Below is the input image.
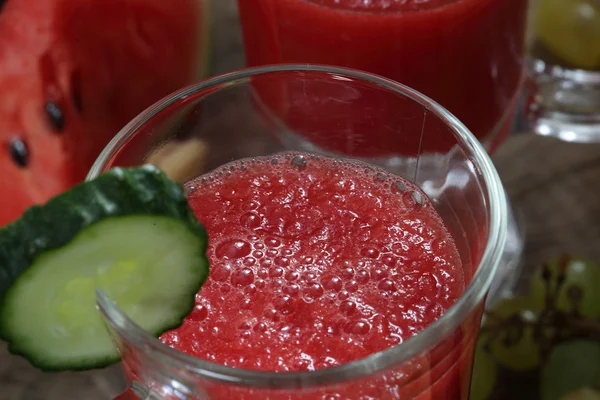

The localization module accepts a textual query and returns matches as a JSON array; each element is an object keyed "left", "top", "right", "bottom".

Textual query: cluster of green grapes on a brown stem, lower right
[{"left": 471, "top": 256, "right": 600, "bottom": 400}]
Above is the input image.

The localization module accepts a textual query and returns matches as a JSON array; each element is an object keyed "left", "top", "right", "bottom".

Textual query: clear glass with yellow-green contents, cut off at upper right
[{"left": 527, "top": 0, "right": 600, "bottom": 143}]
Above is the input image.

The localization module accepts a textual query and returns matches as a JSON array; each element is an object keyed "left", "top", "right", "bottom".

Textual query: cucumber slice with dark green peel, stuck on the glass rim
[{"left": 0, "top": 166, "right": 208, "bottom": 371}]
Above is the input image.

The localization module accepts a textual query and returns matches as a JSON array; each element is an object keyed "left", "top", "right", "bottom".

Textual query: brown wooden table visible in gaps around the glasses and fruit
[{"left": 0, "top": 0, "right": 600, "bottom": 400}]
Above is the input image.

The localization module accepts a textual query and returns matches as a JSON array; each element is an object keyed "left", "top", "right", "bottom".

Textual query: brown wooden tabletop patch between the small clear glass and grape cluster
[{"left": 493, "top": 134, "right": 600, "bottom": 282}]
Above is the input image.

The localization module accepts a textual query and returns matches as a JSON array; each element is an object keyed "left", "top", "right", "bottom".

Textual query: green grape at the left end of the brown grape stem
[{"left": 481, "top": 297, "right": 540, "bottom": 371}]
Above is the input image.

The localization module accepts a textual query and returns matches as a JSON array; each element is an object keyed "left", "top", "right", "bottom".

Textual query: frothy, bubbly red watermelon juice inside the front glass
[{"left": 161, "top": 153, "right": 476, "bottom": 399}]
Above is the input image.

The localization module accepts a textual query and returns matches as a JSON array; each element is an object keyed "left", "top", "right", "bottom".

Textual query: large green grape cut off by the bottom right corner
[{"left": 540, "top": 340, "right": 600, "bottom": 400}]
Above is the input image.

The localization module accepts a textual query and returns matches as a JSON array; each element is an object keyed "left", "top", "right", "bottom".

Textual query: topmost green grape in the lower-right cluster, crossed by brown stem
[{"left": 530, "top": 259, "right": 600, "bottom": 318}]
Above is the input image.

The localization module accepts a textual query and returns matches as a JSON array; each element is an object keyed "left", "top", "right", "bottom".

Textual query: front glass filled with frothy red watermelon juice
[{"left": 88, "top": 65, "right": 507, "bottom": 400}]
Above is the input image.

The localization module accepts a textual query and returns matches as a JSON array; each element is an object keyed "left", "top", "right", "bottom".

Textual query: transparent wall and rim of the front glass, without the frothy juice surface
[{"left": 88, "top": 65, "right": 507, "bottom": 400}]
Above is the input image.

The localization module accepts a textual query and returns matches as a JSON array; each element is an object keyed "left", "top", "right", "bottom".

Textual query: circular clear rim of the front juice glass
[{"left": 86, "top": 64, "right": 508, "bottom": 389}]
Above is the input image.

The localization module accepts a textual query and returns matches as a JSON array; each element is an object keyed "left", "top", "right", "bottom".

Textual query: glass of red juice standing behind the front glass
[{"left": 238, "top": 0, "right": 528, "bottom": 155}]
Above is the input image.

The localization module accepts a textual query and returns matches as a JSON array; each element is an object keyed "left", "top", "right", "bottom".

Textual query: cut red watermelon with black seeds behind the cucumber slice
[{"left": 0, "top": 0, "right": 207, "bottom": 226}]
